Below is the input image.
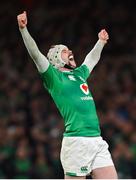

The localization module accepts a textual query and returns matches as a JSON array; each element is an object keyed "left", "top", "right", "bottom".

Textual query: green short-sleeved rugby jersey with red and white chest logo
[{"left": 40, "top": 64, "right": 100, "bottom": 136}]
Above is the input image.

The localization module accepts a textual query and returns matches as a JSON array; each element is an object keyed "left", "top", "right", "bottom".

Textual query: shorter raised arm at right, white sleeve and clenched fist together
[{"left": 83, "top": 29, "right": 109, "bottom": 72}]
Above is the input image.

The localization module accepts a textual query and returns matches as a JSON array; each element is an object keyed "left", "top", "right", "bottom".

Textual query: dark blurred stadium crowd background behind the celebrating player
[{"left": 0, "top": 0, "right": 136, "bottom": 179}]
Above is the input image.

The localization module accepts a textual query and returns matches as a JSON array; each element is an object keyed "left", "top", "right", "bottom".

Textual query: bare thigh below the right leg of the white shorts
[{"left": 91, "top": 166, "right": 118, "bottom": 179}]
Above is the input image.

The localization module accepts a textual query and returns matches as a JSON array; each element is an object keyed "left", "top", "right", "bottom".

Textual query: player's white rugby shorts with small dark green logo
[{"left": 61, "top": 137, "right": 113, "bottom": 176}]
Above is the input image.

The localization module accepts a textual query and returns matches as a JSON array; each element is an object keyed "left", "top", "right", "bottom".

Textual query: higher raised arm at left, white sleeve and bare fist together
[{"left": 17, "top": 11, "right": 49, "bottom": 73}]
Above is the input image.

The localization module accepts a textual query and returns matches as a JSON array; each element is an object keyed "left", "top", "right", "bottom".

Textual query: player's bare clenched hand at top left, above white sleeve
[{"left": 17, "top": 11, "right": 27, "bottom": 29}]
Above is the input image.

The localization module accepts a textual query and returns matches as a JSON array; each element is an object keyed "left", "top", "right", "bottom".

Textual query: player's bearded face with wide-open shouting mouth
[{"left": 61, "top": 48, "right": 76, "bottom": 68}]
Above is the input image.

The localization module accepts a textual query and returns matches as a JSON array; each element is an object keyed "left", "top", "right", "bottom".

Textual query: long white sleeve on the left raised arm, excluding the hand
[{"left": 20, "top": 27, "right": 49, "bottom": 73}]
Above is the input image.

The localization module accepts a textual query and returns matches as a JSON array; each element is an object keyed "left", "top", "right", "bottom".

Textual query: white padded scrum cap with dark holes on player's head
[{"left": 47, "top": 44, "right": 67, "bottom": 68}]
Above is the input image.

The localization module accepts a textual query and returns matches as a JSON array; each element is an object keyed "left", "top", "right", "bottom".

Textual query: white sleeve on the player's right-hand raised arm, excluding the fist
[{"left": 83, "top": 39, "right": 105, "bottom": 72}]
